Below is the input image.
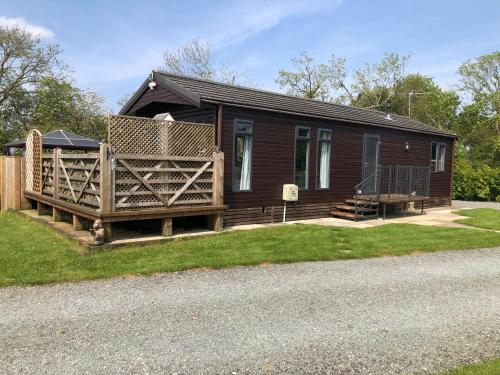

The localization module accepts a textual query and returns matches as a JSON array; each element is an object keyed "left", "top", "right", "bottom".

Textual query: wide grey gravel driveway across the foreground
[{"left": 0, "top": 248, "right": 500, "bottom": 374}]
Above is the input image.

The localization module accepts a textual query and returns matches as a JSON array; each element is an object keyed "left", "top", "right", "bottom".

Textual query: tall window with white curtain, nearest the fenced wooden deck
[{"left": 233, "top": 120, "right": 253, "bottom": 191}]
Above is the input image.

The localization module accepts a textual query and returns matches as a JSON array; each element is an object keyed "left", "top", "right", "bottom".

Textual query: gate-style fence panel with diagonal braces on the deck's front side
[{"left": 114, "top": 154, "right": 213, "bottom": 211}]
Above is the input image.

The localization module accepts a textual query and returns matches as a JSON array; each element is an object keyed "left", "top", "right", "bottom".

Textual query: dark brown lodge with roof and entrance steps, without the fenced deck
[{"left": 120, "top": 72, "right": 456, "bottom": 226}]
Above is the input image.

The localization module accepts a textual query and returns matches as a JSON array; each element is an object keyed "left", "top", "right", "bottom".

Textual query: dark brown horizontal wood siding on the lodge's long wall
[{"left": 222, "top": 106, "right": 453, "bottom": 209}]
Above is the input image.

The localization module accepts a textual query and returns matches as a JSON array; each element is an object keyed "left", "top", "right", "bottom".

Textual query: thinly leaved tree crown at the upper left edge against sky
[{"left": 0, "top": 27, "right": 62, "bottom": 106}]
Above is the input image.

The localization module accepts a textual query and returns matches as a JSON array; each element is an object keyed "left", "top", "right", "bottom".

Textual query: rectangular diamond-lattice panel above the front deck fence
[{"left": 108, "top": 115, "right": 215, "bottom": 156}]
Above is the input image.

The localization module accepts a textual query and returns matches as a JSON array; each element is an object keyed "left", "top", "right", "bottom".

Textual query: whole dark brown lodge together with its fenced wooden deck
[{"left": 17, "top": 72, "right": 455, "bottom": 244}]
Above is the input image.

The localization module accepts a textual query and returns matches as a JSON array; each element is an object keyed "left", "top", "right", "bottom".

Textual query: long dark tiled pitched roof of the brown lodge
[{"left": 124, "top": 72, "right": 456, "bottom": 137}]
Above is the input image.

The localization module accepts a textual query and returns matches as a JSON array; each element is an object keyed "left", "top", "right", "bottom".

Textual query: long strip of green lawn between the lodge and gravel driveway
[{"left": 0, "top": 212, "right": 500, "bottom": 286}]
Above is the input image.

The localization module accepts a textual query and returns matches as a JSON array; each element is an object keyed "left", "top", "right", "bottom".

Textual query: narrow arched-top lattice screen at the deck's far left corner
[{"left": 25, "top": 129, "right": 43, "bottom": 193}]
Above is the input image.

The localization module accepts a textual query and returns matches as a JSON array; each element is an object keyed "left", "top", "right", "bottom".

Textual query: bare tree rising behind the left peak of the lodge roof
[{"left": 160, "top": 39, "right": 255, "bottom": 86}]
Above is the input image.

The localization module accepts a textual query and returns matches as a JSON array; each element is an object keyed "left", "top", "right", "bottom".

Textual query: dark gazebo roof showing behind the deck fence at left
[{"left": 4, "top": 130, "right": 100, "bottom": 150}]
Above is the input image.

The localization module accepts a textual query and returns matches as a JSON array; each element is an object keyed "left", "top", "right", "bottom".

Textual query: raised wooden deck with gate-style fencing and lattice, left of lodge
[{"left": 25, "top": 116, "right": 226, "bottom": 244}]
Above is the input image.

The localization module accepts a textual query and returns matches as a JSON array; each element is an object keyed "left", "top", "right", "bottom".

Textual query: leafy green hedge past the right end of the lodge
[{"left": 453, "top": 159, "right": 500, "bottom": 202}]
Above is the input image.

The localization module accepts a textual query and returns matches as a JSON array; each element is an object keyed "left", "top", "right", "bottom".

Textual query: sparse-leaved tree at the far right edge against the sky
[{"left": 458, "top": 51, "right": 500, "bottom": 137}]
